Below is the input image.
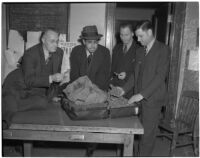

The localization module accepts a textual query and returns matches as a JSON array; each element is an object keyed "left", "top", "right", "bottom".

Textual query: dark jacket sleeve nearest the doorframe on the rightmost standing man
[{"left": 140, "top": 47, "right": 170, "bottom": 99}]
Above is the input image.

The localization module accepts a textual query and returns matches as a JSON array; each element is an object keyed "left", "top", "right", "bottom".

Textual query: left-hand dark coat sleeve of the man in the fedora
[{"left": 70, "top": 47, "right": 79, "bottom": 82}]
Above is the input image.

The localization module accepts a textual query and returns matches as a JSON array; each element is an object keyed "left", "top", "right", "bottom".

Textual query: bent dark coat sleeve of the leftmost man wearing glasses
[{"left": 22, "top": 52, "right": 49, "bottom": 88}]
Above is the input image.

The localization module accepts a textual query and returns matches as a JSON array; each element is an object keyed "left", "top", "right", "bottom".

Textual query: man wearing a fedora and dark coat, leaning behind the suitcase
[{"left": 70, "top": 25, "right": 111, "bottom": 91}]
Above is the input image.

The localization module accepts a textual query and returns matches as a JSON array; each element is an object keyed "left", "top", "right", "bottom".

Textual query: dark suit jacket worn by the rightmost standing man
[{"left": 123, "top": 40, "right": 170, "bottom": 107}]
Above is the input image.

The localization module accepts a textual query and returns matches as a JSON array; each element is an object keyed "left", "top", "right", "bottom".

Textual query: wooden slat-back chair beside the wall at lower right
[{"left": 157, "top": 91, "right": 199, "bottom": 156}]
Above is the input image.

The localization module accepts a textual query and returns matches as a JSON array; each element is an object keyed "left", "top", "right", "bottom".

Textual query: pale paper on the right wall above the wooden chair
[{"left": 188, "top": 49, "right": 199, "bottom": 71}]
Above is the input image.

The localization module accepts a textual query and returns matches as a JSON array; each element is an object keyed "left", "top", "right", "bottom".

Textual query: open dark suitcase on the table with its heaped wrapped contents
[{"left": 61, "top": 76, "right": 136, "bottom": 120}]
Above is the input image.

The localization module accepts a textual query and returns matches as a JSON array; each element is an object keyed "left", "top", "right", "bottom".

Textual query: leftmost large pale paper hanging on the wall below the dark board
[{"left": 8, "top": 30, "right": 24, "bottom": 56}]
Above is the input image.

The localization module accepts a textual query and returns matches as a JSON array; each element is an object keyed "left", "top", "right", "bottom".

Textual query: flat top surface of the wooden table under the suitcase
[{"left": 10, "top": 105, "right": 144, "bottom": 134}]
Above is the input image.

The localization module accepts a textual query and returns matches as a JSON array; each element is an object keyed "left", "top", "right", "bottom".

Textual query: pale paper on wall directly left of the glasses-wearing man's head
[{"left": 26, "top": 31, "right": 42, "bottom": 49}]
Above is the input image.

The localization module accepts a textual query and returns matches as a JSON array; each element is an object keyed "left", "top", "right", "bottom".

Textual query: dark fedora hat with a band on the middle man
[{"left": 80, "top": 25, "right": 103, "bottom": 40}]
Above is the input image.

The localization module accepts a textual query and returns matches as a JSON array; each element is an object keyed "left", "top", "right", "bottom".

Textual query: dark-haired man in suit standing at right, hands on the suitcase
[{"left": 115, "top": 20, "right": 170, "bottom": 156}]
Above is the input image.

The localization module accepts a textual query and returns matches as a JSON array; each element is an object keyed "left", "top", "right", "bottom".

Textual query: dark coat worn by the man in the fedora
[{"left": 70, "top": 45, "right": 111, "bottom": 90}]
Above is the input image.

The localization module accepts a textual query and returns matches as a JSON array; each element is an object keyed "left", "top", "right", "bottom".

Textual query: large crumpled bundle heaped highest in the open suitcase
[{"left": 63, "top": 76, "right": 107, "bottom": 105}]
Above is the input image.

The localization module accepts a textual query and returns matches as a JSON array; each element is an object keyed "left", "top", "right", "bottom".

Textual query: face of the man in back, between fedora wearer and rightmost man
[{"left": 120, "top": 27, "right": 134, "bottom": 44}]
